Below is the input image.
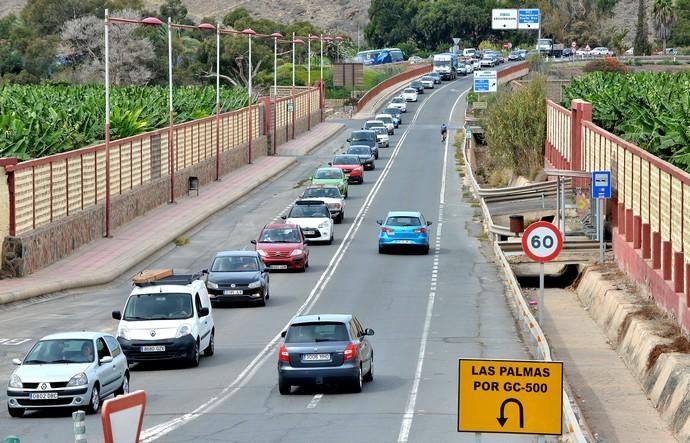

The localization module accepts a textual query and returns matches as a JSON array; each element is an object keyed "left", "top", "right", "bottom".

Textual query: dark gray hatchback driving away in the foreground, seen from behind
[{"left": 278, "top": 314, "right": 374, "bottom": 395}]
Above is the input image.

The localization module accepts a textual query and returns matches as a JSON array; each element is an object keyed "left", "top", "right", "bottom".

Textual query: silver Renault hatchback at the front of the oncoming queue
[{"left": 7, "top": 332, "right": 129, "bottom": 417}]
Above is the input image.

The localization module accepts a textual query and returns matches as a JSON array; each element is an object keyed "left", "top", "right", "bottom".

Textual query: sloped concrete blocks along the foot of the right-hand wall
[{"left": 576, "top": 268, "right": 690, "bottom": 442}]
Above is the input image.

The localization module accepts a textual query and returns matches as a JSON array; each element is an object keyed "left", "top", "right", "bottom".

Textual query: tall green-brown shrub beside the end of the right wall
[{"left": 483, "top": 76, "right": 546, "bottom": 178}]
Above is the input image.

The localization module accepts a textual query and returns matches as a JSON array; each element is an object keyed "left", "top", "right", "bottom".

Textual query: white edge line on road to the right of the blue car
[{"left": 398, "top": 88, "right": 469, "bottom": 443}]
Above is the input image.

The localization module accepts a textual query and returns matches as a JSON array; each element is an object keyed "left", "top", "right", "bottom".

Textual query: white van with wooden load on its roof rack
[{"left": 112, "top": 269, "right": 215, "bottom": 366}]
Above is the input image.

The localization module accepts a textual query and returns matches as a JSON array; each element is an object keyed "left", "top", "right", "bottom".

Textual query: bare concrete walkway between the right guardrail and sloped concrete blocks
[{"left": 544, "top": 288, "right": 677, "bottom": 443}]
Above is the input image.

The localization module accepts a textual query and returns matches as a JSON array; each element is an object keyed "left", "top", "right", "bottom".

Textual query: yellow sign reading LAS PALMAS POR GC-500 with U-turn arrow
[{"left": 458, "top": 358, "right": 563, "bottom": 435}]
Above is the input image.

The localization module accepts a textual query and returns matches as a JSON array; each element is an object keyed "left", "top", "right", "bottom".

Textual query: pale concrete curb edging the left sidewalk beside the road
[{"left": 0, "top": 157, "right": 297, "bottom": 304}]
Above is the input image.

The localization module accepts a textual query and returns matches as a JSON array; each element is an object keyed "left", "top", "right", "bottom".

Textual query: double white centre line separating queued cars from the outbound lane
[{"left": 141, "top": 81, "right": 448, "bottom": 443}]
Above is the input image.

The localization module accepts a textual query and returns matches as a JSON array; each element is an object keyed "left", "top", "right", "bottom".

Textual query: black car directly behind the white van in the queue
[{"left": 206, "top": 251, "right": 270, "bottom": 306}]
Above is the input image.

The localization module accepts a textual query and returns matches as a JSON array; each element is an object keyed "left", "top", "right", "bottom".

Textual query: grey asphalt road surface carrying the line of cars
[{"left": 0, "top": 67, "right": 534, "bottom": 443}]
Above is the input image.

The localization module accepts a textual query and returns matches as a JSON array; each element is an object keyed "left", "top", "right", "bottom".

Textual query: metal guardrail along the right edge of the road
[{"left": 463, "top": 140, "right": 589, "bottom": 443}]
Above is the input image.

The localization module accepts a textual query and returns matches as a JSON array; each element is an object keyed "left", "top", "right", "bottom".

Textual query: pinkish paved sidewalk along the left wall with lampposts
[{"left": 0, "top": 123, "right": 344, "bottom": 304}]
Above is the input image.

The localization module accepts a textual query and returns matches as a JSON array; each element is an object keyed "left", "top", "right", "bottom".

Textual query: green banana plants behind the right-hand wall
[{"left": 563, "top": 72, "right": 690, "bottom": 171}]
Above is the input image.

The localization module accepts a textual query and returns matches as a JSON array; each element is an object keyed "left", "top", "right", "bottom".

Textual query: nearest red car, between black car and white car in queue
[{"left": 252, "top": 223, "right": 309, "bottom": 272}]
